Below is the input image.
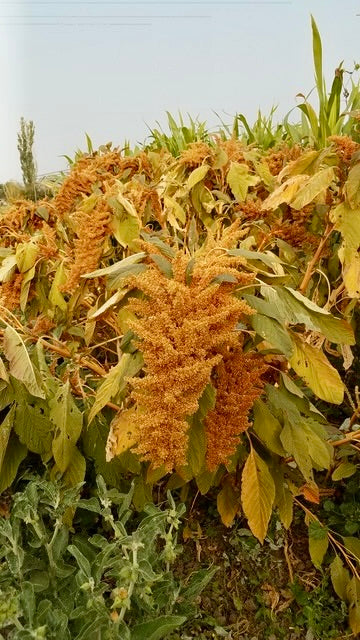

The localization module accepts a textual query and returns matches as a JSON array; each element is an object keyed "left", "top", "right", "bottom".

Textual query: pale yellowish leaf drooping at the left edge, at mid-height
[{"left": 3, "top": 325, "right": 45, "bottom": 398}]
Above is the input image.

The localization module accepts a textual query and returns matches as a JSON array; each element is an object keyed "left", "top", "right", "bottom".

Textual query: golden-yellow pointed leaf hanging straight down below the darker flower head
[{"left": 241, "top": 448, "right": 275, "bottom": 543}]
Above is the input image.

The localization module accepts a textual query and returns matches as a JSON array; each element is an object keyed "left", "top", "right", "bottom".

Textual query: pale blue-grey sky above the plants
[{"left": 0, "top": 0, "right": 360, "bottom": 182}]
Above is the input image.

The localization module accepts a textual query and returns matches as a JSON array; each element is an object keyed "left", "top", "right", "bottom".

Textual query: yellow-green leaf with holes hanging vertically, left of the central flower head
[{"left": 49, "top": 381, "right": 82, "bottom": 473}]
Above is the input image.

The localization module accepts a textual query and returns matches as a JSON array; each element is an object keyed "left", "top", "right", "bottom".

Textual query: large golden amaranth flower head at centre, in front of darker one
[{"left": 125, "top": 248, "right": 253, "bottom": 471}]
